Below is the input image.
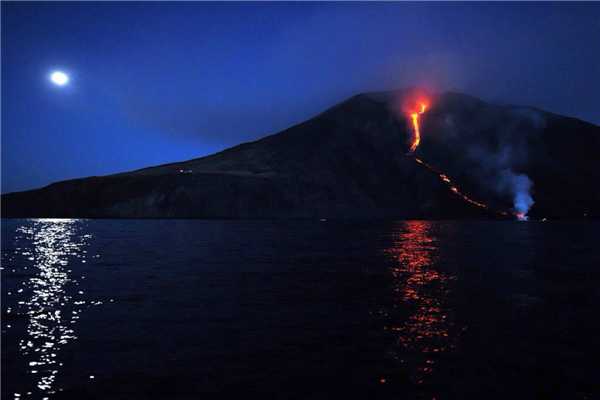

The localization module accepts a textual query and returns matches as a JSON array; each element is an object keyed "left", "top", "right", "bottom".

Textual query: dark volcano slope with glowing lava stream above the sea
[{"left": 2, "top": 90, "right": 600, "bottom": 219}]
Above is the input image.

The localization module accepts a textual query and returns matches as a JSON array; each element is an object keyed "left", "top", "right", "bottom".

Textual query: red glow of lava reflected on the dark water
[{"left": 386, "top": 221, "right": 454, "bottom": 384}]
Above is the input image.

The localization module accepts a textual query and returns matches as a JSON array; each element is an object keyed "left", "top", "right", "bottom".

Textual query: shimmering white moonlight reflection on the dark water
[{"left": 6, "top": 219, "right": 90, "bottom": 399}]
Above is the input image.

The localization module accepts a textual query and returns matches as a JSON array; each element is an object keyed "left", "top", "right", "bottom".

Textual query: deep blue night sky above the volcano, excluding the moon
[{"left": 2, "top": 2, "right": 600, "bottom": 192}]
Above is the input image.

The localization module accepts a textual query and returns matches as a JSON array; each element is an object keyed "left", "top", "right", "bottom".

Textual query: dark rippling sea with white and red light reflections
[{"left": 1, "top": 220, "right": 600, "bottom": 400}]
